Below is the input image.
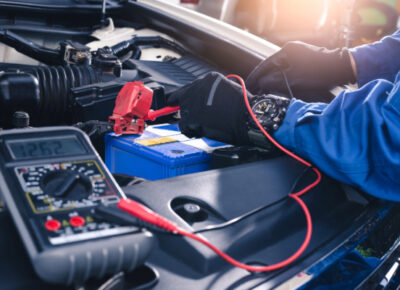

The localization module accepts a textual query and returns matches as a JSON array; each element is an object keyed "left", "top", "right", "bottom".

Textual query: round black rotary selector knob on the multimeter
[{"left": 41, "top": 170, "right": 92, "bottom": 200}]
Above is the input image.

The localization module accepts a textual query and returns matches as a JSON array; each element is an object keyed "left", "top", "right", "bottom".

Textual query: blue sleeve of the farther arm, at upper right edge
[{"left": 350, "top": 30, "right": 400, "bottom": 87}]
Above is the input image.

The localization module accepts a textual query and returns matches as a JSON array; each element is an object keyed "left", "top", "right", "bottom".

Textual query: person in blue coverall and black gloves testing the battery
[{"left": 168, "top": 31, "right": 400, "bottom": 201}]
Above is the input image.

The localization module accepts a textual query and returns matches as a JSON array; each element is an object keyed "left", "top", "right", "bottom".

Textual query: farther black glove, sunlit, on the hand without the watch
[{"left": 246, "top": 42, "right": 356, "bottom": 96}]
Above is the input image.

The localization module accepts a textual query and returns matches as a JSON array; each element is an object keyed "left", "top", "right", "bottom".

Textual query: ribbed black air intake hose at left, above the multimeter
[{"left": 0, "top": 64, "right": 102, "bottom": 125}]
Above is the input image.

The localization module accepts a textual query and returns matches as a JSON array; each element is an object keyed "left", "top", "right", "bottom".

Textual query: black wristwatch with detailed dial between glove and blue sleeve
[{"left": 248, "top": 94, "right": 290, "bottom": 150}]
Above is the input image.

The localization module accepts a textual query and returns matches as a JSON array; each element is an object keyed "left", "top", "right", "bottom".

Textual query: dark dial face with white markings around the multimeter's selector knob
[{"left": 15, "top": 160, "right": 118, "bottom": 213}]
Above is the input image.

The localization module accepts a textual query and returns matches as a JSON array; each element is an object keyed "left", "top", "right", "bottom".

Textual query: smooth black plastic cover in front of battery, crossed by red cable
[{"left": 124, "top": 157, "right": 367, "bottom": 274}]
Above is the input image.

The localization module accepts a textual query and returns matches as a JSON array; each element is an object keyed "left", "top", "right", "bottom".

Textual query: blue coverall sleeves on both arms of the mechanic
[{"left": 274, "top": 30, "right": 400, "bottom": 201}]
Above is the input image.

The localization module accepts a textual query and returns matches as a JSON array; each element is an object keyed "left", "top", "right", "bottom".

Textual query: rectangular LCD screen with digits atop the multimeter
[{"left": 7, "top": 136, "right": 85, "bottom": 160}]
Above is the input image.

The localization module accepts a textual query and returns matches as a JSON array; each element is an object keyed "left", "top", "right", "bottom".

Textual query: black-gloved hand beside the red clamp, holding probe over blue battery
[{"left": 168, "top": 72, "right": 253, "bottom": 145}]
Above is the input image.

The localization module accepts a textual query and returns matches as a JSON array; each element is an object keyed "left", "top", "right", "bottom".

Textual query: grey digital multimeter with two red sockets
[{"left": 0, "top": 127, "right": 154, "bottom": 285}]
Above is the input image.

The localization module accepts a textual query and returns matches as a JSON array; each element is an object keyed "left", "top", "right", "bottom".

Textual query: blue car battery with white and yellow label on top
[{"left": 105, "top": 124, "right": 230, "bottom": 180}]
